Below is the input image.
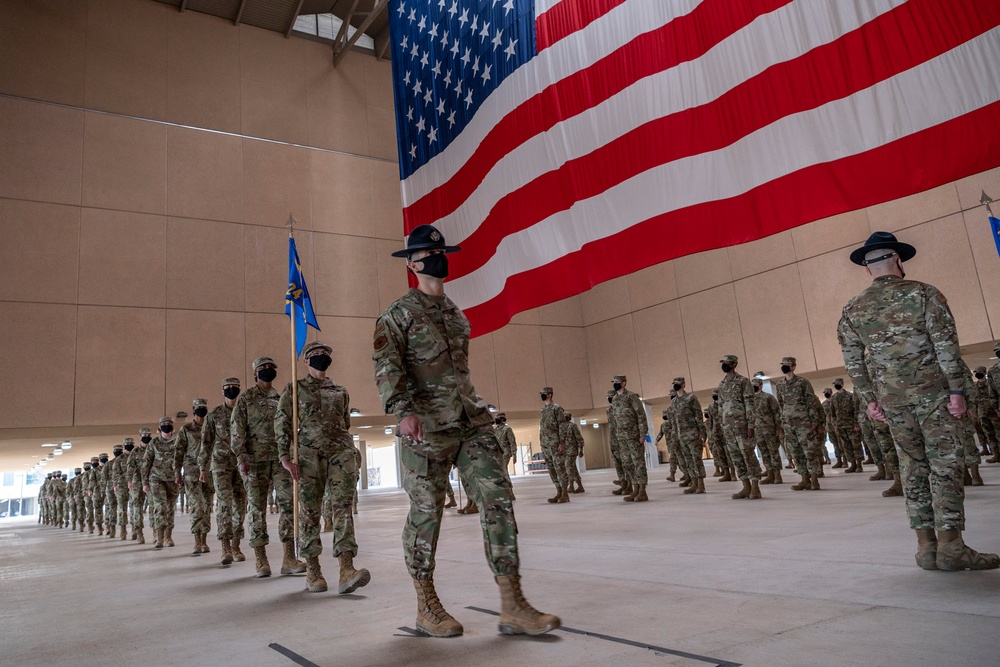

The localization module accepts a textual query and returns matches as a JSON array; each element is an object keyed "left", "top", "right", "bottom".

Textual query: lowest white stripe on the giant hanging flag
[{"left": 448, "top": 28, "right": 1000, "bottom": 308}]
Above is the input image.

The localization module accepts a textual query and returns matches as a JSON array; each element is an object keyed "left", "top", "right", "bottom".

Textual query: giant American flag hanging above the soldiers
[{"left": 389, "top": 0, "right": 1000, "bottom": 335}]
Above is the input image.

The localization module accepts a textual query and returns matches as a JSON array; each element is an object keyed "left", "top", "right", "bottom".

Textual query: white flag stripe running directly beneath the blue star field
[{"left": 402, "top": 0, "right": 702, "bottom": 207}]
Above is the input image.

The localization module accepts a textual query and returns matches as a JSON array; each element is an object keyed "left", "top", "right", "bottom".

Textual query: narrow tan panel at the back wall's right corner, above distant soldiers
[{"left": 537, "top": 327, "right": 593, "bottom": 412}]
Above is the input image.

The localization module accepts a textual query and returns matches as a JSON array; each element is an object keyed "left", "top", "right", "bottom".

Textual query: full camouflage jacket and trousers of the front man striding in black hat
[{"left": 372, "top": 289, "right": 520, "bottom": 580}]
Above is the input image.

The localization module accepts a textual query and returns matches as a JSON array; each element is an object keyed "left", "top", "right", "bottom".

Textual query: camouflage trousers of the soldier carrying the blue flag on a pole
[{"left": 299, "top": 445, "right": 361, "bottom": 557}]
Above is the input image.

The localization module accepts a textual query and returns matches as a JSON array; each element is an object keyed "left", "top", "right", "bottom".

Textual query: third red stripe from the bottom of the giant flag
[{"left": 403, "top": 0, "right": 793, "bottom": 234}]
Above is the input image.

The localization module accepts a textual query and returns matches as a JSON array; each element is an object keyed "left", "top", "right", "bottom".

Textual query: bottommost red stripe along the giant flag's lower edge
[{"left": 465, "top": 102, "right": 1000, "bottom": 336}]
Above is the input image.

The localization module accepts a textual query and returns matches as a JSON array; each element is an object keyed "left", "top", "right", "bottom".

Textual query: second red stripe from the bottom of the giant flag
[{"left": 450, "top": 0, "right": 1000, "bottom": 279}]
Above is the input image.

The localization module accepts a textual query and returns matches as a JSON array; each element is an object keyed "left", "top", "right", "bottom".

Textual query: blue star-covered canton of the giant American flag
[{"left": 389, "top": 0, "right": 535, "bottom": 179}]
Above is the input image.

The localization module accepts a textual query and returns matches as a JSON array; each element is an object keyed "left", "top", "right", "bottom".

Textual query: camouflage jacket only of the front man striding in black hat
[{"left": 372, "top": 289, "right": 493, "bottom": 433}]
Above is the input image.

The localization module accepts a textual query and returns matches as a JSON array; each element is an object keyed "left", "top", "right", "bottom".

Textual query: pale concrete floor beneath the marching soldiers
[{"left": 0, "top": 465, "right": 1000, "bottom": 667}]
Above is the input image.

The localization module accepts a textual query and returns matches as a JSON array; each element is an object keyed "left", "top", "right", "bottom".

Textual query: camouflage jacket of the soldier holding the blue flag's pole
[{"left": 274, "top": 375, "right": 354, "bottom": 461}]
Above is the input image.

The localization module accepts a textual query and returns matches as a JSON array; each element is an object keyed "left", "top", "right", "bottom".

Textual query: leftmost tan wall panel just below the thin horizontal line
[{"left": 0, "top": 98, "right": 83, "bottom": 204}]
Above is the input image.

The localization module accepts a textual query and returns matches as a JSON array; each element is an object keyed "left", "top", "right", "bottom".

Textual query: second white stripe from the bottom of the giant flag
[{"left": 432, "top": 0, "right": 906, "bottom": 243}]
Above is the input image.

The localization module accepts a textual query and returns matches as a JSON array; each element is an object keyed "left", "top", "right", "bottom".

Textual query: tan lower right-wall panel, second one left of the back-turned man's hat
[{"left": 735, "top": 265, "right": 816, "bottom": 377}]
